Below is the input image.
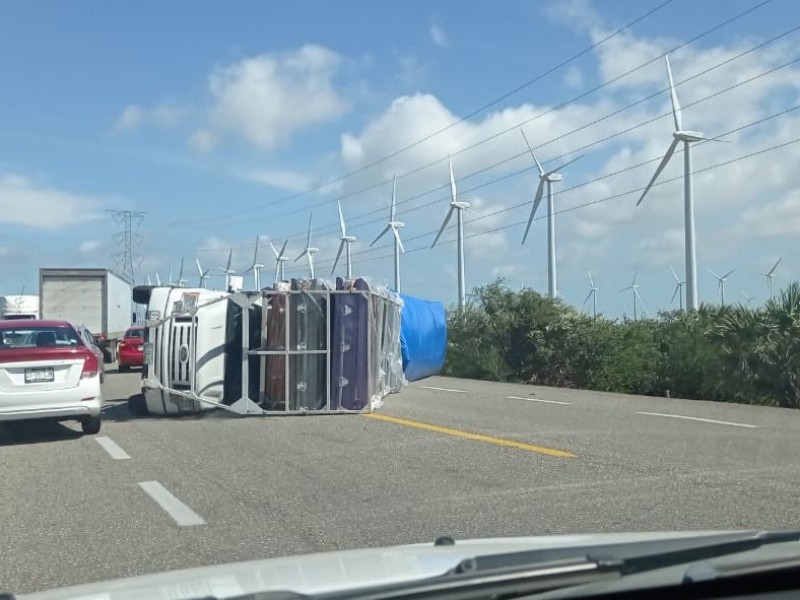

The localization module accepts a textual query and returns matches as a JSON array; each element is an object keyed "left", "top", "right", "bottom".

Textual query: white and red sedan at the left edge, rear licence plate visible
[{"left": 0, "top": 320, "right": 103, "bottom": 434}]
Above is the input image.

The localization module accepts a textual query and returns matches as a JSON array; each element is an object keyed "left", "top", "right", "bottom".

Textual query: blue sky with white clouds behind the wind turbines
[{"left": 0, "top": 0, "right": 800, "bottom": 316}]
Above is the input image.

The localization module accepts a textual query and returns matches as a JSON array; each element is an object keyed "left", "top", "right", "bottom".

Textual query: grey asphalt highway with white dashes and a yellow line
[{"left": 0, "top": 370, "right": 800, "bottom": 593}]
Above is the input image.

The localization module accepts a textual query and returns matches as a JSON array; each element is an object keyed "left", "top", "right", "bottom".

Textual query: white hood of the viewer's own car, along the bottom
[{"left": 18, "top": 531, "right": 744, "bottom": 600}]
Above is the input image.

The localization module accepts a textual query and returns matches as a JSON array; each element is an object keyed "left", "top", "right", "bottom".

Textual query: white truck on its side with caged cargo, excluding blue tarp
[{"left": 134, "top": 278, "right": 405, "bottom": 415}]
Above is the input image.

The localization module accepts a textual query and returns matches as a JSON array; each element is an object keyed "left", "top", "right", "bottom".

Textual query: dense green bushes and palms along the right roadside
[{"left": 443, "top": 280, "right": 800, "bottom": 408}]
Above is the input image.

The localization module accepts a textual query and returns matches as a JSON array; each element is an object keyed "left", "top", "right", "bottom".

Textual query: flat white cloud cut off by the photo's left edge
[{"left": 0, "top": 173, "right": 100, "bottom": 229}]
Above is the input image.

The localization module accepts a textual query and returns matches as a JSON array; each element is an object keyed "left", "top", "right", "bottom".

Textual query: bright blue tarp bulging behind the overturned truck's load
[{"left": 400, "top": 294, "right": 447, "bottom": 381}]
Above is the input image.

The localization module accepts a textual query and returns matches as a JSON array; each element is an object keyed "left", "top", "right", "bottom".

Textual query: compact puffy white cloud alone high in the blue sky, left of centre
[{"left": 209, "top": 44, "right": 346, "bottom": 149}]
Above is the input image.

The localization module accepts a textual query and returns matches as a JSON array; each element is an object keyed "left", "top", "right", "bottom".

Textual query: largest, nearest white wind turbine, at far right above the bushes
[{"left": 636, "top": 56, "right": 719, "bottom": 311}]
